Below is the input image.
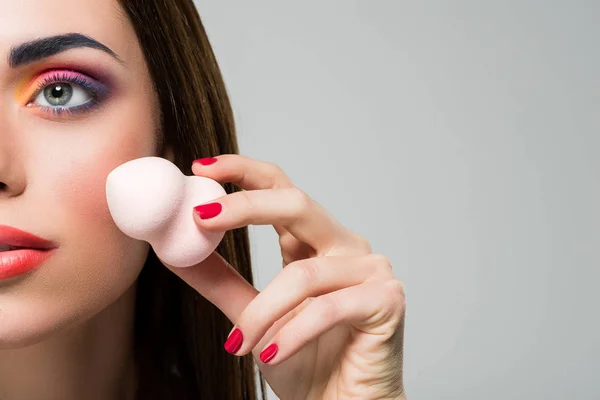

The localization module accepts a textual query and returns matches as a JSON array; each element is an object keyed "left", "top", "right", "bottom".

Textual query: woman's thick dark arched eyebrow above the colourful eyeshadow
[{"left": 8, "top": 33, "right": 123, "bottom": 68}]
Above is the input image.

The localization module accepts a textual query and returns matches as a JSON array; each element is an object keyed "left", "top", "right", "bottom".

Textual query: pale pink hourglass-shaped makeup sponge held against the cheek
[{"left": 106, "top": 157, "right": 227, "bottom": 267}]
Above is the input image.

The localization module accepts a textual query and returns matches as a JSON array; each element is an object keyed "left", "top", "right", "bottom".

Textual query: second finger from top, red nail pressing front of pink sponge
[{"left": 194, "top": 188, "right": 347, "bottom": 252}]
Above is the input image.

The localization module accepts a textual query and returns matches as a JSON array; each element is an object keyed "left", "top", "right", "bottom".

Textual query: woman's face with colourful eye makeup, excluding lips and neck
[{"left": 0, "top": 0, "right": 158, "bottom": 348}]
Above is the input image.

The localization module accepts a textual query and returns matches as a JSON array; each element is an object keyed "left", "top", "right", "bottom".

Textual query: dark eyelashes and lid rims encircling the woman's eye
[{"left": 28, "top": 70, "right": 108, "bottom": 117}]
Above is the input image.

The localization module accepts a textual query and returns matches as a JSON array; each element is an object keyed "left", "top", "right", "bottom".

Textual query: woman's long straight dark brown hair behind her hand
[{"left": 119, "top": 0, "right": 265, "bottom": 400}]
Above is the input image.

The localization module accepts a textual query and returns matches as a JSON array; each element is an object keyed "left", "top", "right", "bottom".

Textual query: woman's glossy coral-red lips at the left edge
[{"left": 0, "top": 225, "right": 57, "bottom": 280}]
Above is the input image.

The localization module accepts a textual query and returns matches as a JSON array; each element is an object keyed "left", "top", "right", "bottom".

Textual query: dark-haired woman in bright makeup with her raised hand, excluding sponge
[{"left": 0, "top": 0, "right": 405, "bottom": 400}]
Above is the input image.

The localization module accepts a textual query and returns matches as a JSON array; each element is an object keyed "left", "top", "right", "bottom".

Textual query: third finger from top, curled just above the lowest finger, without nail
[{"left": 218, "top": 254, "right": 393, "bottom": 355}]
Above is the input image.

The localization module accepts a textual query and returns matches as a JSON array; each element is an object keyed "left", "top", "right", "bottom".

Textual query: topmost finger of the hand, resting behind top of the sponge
[{"left": 192, "top": 154, "right": 294, "bottom": 190}]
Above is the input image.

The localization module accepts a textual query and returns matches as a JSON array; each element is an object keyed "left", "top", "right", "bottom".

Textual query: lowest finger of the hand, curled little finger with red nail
[{"left": 254, "top": 280, "right": 405, "bottom": 365}]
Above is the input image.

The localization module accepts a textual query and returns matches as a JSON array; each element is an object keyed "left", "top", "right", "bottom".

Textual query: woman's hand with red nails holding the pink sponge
[{"left": 164, "top": 154, "right": 405, "bottom": 400}]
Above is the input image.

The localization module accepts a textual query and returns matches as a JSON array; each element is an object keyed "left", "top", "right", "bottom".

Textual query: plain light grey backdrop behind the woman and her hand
[{"left": 197, "top": 0, "right": 600, "bottom": 400}]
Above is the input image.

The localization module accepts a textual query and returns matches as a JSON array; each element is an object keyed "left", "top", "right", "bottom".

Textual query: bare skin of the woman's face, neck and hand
[{"left": 0, "top": 0, "right": 405, "bottom": 400}]
